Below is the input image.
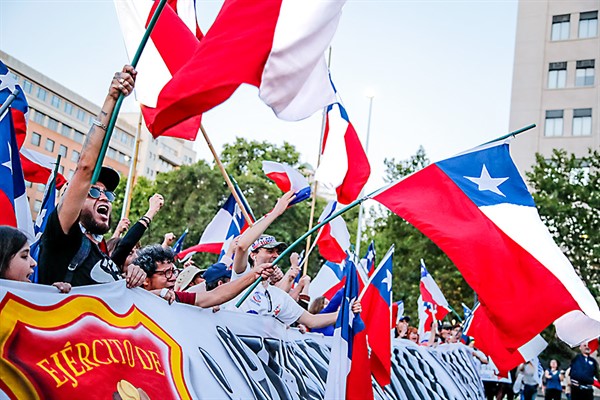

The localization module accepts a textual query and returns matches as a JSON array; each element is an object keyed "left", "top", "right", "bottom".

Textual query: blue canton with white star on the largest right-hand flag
[{"left": 437, "top": 143, "right": 535, "bottom": 207}]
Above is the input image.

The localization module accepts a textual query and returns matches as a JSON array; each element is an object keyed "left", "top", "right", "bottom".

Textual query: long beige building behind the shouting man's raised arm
[{"left": 0, "top": 51, "right": 196, "bottom": 219}]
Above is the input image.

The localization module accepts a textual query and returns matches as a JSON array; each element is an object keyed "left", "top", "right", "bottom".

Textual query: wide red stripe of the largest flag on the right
[{"left": 374, "top": 165, "right": 579, "bottom": 349}]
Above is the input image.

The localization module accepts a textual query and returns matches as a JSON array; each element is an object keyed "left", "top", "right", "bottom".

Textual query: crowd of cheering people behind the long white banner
[{"left": 0, "top": 66, "right": 598, "bottom": 400}]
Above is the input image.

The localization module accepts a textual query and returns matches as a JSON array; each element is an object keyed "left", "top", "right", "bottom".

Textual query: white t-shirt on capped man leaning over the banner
[{"left": 225, "top": 276, "right": 304, "bottom": 325}]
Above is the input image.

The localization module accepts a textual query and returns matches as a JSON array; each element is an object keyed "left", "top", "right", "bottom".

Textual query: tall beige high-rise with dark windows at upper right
[{"left": 510, "top": 0, "right": 600, "bottom": 171}]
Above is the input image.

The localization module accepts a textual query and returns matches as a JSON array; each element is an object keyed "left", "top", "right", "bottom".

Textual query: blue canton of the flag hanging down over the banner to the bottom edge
[{"left": 335, "top": 260, "right": 365, "bottom": 360}]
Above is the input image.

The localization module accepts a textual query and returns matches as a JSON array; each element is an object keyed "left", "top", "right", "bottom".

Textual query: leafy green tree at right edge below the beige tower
[{"left": 527, "top": 149, "right": 600, "bottom": 301}]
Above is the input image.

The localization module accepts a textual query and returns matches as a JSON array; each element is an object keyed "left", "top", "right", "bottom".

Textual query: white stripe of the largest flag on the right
[{"left": 480, "top": 204, "right": 600, "bottom": 322}]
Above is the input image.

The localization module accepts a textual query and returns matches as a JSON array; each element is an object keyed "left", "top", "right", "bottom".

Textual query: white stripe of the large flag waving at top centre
[{"left": 260, "top": 0, "right": 344, "bottom": 120}]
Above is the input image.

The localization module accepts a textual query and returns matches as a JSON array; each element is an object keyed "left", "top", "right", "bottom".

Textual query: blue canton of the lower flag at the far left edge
[{"left": 0, "top": 113, "right": 25, "bottom": 203}]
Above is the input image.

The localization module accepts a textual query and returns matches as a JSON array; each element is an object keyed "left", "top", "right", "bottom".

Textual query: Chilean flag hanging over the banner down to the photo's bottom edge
[{"left": 325, "top": 248, "right": 372, "bottom": 400}]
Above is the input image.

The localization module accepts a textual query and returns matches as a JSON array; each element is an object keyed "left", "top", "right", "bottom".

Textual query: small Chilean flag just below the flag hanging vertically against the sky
[{"left": 317, "top": 201, "right": 350, "bottom": 263}]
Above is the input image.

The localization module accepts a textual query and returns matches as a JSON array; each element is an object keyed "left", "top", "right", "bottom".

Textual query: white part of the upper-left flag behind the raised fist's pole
[{"left": 114, "top": 0, "right": 171, "bottom": 107}]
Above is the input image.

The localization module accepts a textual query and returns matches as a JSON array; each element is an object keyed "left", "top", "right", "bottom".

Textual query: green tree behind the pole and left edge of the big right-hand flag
[{"left": 370, "top": 147, "right": 473, "bottom": 319}]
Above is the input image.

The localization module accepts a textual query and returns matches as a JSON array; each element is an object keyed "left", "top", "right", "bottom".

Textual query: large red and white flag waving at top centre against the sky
[{"left": 135, "top": 0, "right": 344, "bottom": 136}]
